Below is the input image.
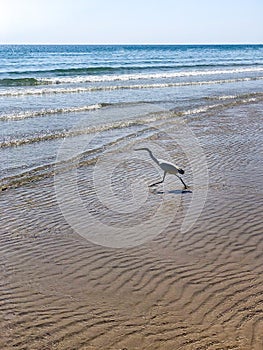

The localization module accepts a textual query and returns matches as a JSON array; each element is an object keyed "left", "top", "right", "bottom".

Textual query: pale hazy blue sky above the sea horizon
[{"left": 0, "top": 0, "right": 263, "bottom": 44}]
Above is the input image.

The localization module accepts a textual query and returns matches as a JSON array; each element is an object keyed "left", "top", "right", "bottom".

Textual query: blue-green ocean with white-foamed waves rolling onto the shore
[{"left": 0, "top": 45, "right": 263, "bottom": 189}]
